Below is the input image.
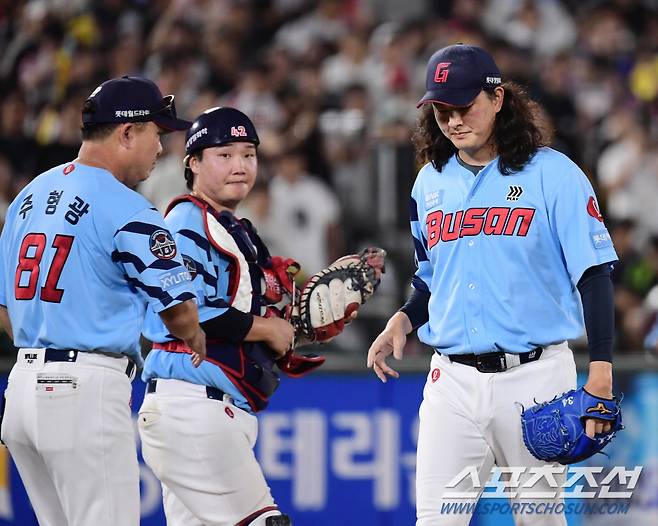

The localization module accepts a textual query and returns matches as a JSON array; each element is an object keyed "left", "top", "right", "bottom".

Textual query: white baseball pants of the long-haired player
[{"left": 416, "top": 343, "right": 576, "bottom": 526}]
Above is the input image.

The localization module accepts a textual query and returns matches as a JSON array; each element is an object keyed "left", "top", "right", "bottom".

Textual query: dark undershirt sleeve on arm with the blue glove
[{"left": 578, "top": 263, "right": 615, "bottom": 363}]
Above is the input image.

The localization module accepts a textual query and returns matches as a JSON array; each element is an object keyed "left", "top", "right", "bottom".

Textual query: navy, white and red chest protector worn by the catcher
[{"left": 167, "top": 194, "right": 279, "bottom": 412}]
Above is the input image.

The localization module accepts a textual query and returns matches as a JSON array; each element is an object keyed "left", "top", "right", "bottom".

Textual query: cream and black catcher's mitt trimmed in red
[{"left": 292, "top": 247, "right": 386, "bottom": 343}]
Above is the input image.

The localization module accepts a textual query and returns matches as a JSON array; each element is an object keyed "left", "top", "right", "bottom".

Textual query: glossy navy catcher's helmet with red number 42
[{"left": 185, "top": 106, "right": 260, "bottom": 155}]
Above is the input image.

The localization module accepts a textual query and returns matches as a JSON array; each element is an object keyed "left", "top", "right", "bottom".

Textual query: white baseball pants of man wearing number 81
[{"left": 2, "top": 349, "right": 139, "bottom": 526}]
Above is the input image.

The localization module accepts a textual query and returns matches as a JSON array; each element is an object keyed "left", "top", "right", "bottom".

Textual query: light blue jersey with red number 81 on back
[{"left": 0, "top": 163, "right": 194, "bottom": 364}]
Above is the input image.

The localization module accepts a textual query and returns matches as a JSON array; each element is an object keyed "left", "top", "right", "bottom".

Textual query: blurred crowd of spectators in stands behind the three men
[{"left": 0, "top": 0, "right": 658, "bottom": 355}]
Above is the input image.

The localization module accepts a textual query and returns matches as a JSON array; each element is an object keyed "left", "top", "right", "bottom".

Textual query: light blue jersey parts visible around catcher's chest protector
[{"left": 142, "top": 202, "right": 252, "bottom": 412}]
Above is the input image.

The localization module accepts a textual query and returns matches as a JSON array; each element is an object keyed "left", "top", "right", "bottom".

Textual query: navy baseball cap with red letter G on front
[{"left": 416, "top": 44, "right": 502, "bottom": 108}]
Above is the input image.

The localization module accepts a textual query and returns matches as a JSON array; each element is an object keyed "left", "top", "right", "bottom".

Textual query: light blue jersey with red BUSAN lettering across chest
[{"left": 410, "top": 148, "right": 617, "bottom": 354}]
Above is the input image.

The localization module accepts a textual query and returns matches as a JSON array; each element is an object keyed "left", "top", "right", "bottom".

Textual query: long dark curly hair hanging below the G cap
[{"left": 412, "top": 82, "right": 552, "bottom": 175}]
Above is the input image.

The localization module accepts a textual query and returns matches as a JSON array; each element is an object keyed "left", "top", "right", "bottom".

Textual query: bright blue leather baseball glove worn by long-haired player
[{"left": 521, "top": 387, "right": 624, "bottom": 464}]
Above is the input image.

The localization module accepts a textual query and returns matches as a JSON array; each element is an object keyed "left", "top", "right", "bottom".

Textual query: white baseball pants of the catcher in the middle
[{"left": 139, "top": 380, "right": 274, "bottom": 526}]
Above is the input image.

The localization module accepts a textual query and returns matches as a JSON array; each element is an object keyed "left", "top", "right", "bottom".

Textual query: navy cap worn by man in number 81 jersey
[{"left": 82, "top": 75, "right": 192, "bottom": 131}]
